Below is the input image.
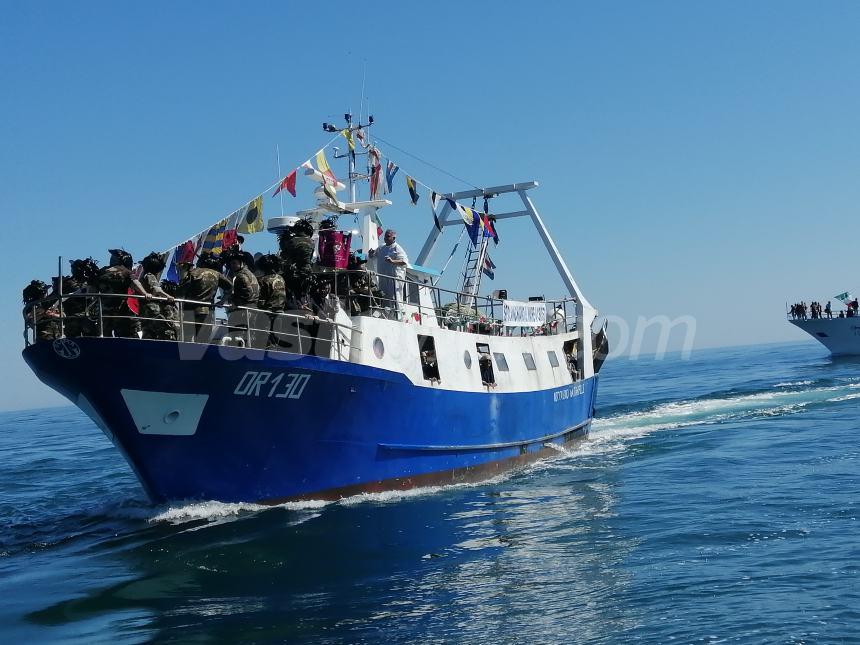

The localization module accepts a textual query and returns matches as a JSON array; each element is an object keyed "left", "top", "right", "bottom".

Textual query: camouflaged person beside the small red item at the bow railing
[{"left": 96, "top": 249, "right": 149, "bottom": 338}]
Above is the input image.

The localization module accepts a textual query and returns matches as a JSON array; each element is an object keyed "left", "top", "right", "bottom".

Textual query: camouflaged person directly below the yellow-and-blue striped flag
[{"left": 178, "top": 251, "right": 233, "bottom": 343}]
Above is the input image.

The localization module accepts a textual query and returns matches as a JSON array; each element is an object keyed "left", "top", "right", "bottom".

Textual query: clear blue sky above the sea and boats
[{"left": 0, "top": 0, "right": 860, "bottom": 408}]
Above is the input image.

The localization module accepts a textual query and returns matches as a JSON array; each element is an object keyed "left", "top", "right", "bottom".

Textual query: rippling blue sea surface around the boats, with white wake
[{"left": 0, "top": 343, "right": 860, "bottom": 644}]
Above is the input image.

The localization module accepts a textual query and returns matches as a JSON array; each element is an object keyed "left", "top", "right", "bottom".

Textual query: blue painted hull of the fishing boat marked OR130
[{"left": 24, "top": 338, "right": 597, "bottom": 503}]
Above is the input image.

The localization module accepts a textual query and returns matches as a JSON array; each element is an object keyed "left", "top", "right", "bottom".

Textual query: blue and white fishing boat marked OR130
[{"left": 23, "top": 119, "right": 608, "bottom": 503}]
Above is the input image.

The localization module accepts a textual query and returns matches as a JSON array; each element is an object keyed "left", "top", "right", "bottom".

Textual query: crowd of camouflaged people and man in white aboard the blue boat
[{"left": 23, "top": 219, "right": 408, "bottom": 348}]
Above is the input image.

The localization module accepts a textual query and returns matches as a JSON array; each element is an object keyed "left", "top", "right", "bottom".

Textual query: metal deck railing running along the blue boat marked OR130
[{"left": 23, "top": 269, "right": 576, "bottom": 350}]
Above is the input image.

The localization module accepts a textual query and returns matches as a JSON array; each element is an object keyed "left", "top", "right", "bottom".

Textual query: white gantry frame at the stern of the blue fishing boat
[{"left": 416, "top": 181, "right": 597, "bottom": 378}]
